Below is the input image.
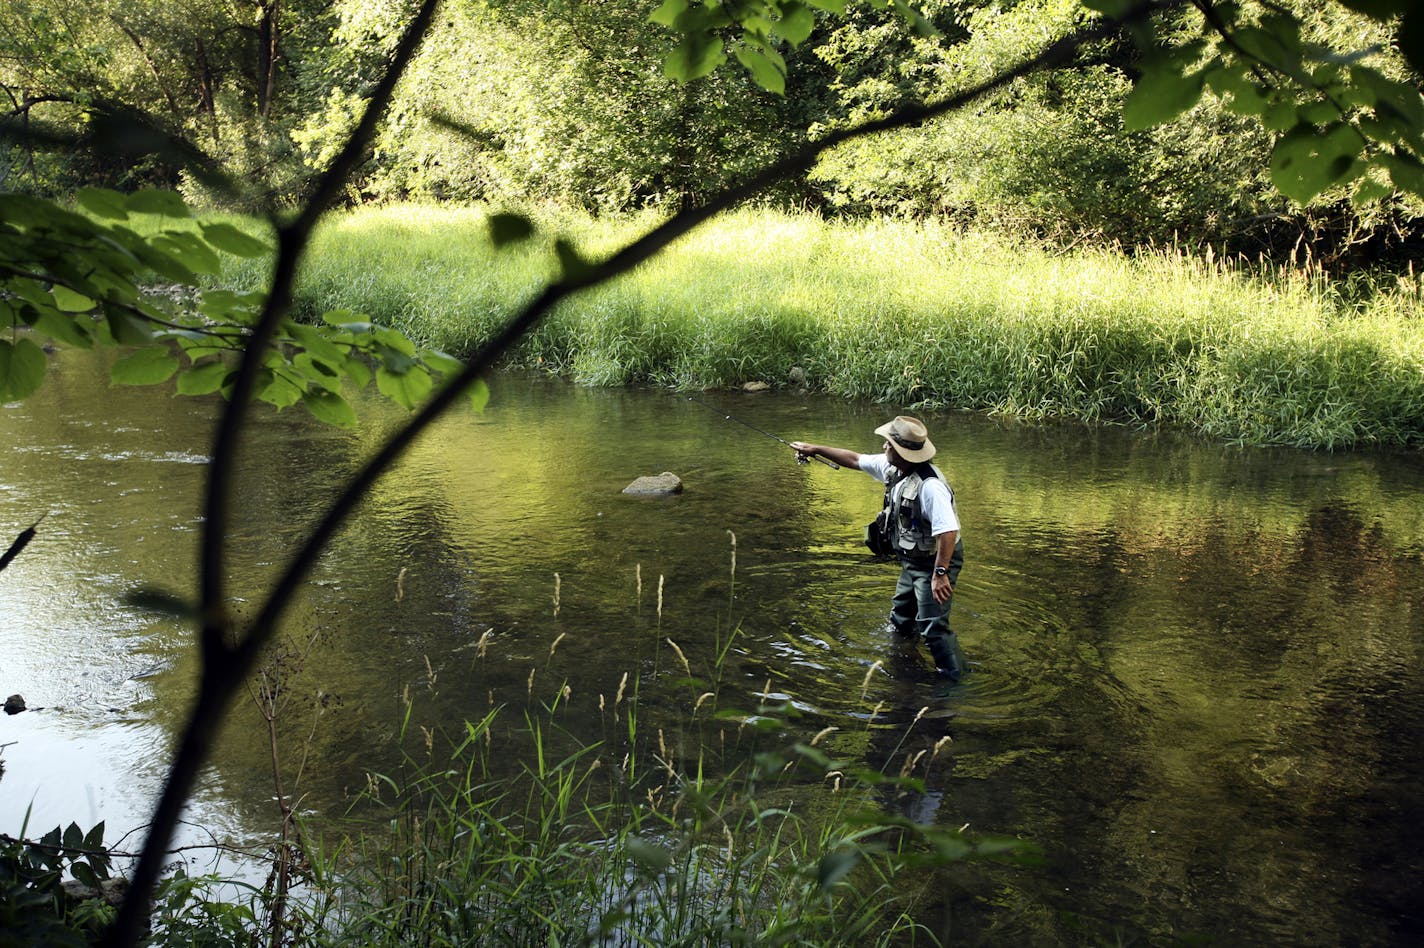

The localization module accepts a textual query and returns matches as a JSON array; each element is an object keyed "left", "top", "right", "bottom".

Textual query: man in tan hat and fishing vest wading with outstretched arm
[{"left": 790, "top": 414, "right": 968, "bottom": 680}]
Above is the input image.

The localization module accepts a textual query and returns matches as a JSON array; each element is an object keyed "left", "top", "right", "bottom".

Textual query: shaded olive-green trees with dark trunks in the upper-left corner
[{"left": 0, "top": 0, "right": 338, "bottom": 202}]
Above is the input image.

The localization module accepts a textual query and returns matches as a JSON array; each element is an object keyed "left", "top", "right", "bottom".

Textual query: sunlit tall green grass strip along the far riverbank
[{"left": 224, "top": 206, "right": 1424, "bottom": 448}]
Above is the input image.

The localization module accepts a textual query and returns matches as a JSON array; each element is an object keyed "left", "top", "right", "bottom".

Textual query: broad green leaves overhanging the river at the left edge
[{"left": 0, "top": 189, "right": 483, "bottom": 418}]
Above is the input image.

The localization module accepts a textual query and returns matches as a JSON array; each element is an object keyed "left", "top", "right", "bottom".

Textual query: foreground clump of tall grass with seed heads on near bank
[{"left": 311, "top": 680, "right": 974, "bottom": 948}]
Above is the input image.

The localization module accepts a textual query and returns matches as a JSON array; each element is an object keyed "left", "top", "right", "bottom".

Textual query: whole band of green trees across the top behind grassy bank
[{"left": 8, "top": 0, "right": 1424, "bottom": 249}]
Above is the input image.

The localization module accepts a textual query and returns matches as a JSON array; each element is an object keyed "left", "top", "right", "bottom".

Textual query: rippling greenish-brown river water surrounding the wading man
[{"left": 0, "top": 353, "right": 1424, "bottom": 945}]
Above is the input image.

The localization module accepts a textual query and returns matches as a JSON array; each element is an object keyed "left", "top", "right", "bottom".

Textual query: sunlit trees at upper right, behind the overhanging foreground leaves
[{"left": 812, "top": 0, "right": 1418, "bottom": 243}]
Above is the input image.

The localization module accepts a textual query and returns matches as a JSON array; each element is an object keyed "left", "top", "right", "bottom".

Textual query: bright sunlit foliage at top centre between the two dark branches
[{"left": 295, "top": 0, "right": 802, "bottom": 209}]
